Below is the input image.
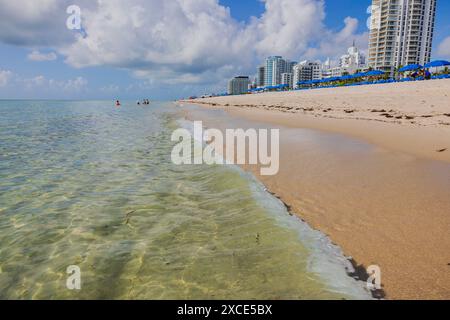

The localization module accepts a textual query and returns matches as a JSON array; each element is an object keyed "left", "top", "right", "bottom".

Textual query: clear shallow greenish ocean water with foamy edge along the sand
[{"left": 0, "top": 101, "right": 370, "bottom": 299}]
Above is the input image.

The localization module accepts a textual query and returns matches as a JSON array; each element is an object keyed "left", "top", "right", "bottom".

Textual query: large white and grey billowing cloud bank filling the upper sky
[{"left": 0, "top": 0, "right": 367, "bottom": 85}]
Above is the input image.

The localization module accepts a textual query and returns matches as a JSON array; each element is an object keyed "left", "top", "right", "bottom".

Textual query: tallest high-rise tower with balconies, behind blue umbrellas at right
[{"left": 368, "top": 0, "right": 436, "bottom": 72}]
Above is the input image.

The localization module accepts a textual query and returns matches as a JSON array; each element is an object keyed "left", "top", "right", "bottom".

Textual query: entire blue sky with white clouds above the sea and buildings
[{"left": 0, "top": 0, "right": 450, "bottom": 99}]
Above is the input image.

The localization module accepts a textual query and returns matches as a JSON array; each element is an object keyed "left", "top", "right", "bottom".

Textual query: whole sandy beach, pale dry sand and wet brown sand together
[{"left": 181, "top": 80, "right": 450, "bottom": 299}]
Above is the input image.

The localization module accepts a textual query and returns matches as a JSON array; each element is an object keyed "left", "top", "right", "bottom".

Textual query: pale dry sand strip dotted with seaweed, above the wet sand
[{"left": 180, "top": 80, "right": 450, "bottom": 162}]
